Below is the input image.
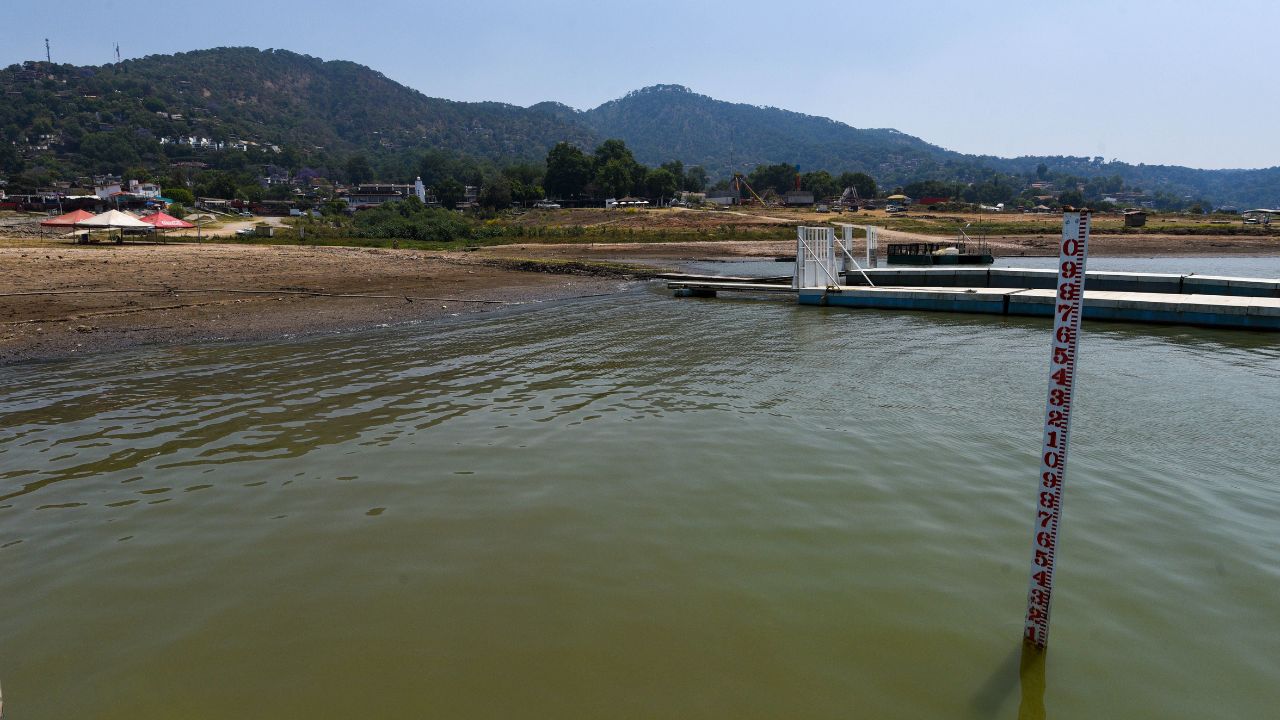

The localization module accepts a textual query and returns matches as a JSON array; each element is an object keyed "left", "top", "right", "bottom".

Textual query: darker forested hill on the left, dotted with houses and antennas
[{"left": 0, "top": 47, "right": 596, "bottom": 172}]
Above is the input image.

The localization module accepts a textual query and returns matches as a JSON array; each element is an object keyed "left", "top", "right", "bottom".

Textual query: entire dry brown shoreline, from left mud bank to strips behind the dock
[{"left": 0, "top": 231, "right": 1280, "bottom": 365}]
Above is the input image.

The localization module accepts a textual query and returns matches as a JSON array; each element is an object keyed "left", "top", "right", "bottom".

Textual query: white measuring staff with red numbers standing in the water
[{"left": 1023, "top": 210, "right": 1091, "bottom": 650}]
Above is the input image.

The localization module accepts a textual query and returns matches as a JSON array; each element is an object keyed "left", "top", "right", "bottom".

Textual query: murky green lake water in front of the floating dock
[{"left": 0, "top": 266, "right": 1280, "bottom": 720}]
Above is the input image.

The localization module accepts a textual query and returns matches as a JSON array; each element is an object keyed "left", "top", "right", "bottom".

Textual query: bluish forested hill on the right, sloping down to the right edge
[{"left": 580, "top": 85, "right": 1280, "bottom": 209}]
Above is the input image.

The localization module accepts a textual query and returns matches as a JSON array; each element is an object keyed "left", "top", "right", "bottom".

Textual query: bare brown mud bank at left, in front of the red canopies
[{"left": 0, "top": 245, "right": 634, "bottom": 364}]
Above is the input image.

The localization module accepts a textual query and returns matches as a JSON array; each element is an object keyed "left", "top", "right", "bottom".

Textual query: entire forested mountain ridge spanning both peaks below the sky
[{"left": 0, "top": 47, "right": 1280, "bottom": 208}]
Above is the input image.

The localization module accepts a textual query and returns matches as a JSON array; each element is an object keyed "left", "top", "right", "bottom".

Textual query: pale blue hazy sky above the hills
[{"left": 0, "top": 0, "right": 1280, "bottom": 168}]
